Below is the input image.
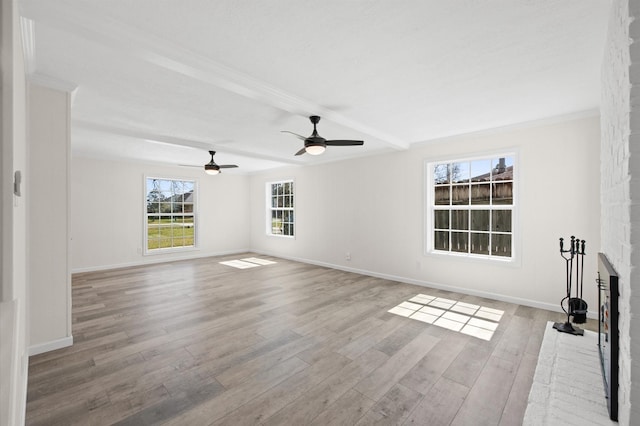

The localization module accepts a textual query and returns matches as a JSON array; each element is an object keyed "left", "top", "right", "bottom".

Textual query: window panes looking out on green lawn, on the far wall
[{"left": 145, "top": 178, "right": 196, "bottom": 252}]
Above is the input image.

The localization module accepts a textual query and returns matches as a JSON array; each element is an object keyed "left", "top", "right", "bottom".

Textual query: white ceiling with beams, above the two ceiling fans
[{"left": 20, "top": 0, "right": 610, "bottom": 173}]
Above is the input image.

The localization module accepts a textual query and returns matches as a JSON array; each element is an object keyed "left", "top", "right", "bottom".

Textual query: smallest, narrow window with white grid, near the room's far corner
[{"left": 267, "top": 180, "right": 295, "bottom": 237}]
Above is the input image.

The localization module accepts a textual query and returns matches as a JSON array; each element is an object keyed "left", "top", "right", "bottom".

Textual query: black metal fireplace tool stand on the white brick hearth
[{"left": 553, "top": 235, "right": 588, "bottom": 336}]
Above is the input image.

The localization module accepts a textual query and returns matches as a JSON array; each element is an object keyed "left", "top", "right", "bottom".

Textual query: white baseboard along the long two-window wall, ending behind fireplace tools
[{"left": 253, "top": 250, "right": 598, "bottom": 319}]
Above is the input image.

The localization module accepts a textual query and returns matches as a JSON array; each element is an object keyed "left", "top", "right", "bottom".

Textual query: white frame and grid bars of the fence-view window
[{"left": 423, "top": 149, "right": 521, "bottom": 266}]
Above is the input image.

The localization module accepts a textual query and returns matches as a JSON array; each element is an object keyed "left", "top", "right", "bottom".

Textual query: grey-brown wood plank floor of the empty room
[{"left": 26, "top": 254, "right": 561, "bottom": 426}]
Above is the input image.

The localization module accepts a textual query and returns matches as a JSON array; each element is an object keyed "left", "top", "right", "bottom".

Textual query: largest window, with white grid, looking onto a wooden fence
[{"left": 426, "top": 154, "right": 516, "bottom": 259}]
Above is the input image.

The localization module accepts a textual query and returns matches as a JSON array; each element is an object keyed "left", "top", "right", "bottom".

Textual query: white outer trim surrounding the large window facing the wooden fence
[{"left": 423, "top": 148, "right": 521, "bottom": 267}]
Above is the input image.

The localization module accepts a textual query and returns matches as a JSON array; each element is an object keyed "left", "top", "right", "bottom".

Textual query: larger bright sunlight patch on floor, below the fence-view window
[{"left": 387, "top": 294, "right": 504, "bottom": 340}]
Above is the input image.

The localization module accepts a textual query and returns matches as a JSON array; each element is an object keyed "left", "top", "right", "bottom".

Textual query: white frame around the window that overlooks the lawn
[{"left": 142, "top": 175, "right": 200, "bottom": 256}]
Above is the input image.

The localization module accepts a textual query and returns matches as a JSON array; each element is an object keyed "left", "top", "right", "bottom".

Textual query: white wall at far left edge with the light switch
[{"left": 0, "top": 0, "right": 29, "bottom": 425}]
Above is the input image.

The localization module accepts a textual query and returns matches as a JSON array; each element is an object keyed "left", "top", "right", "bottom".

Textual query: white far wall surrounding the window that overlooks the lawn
[{"left": 71, "top": 157, "right": 249, "bottom": 272}]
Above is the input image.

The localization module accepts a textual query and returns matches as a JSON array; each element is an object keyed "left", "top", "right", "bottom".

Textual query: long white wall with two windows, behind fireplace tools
[{"left": 251, "top": 116, "right": 600, "bottom": 315}]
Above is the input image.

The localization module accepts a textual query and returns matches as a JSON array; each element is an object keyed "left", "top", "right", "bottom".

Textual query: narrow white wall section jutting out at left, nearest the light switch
[{"left": 28, "top": 84, "right": 73, "bottom": 355}]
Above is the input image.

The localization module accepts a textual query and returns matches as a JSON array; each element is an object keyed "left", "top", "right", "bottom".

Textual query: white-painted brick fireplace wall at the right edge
[{"left": 600, "top": 0, "right": 640, "bottom": 424}]
